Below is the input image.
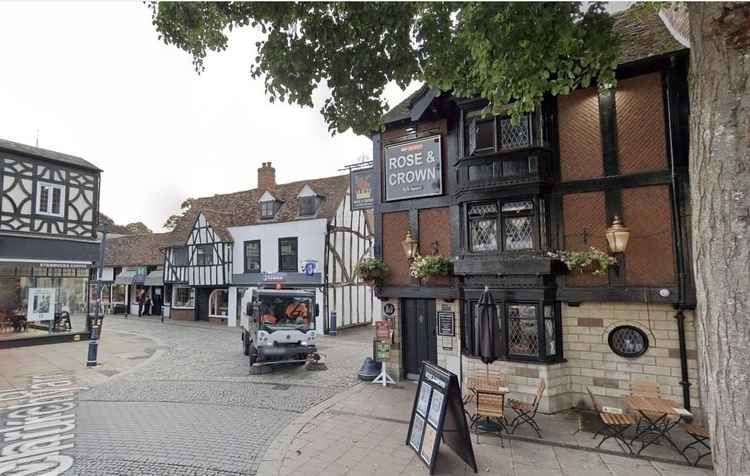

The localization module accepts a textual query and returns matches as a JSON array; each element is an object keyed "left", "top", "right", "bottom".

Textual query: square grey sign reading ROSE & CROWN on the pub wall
[{"left": 383, "top": 136, "right": 443, "bottom": 201}]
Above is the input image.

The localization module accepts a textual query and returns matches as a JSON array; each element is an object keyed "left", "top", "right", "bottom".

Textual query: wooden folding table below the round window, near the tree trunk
[{"left": 625, "top": 395, "right": 687, "bottom": 454}]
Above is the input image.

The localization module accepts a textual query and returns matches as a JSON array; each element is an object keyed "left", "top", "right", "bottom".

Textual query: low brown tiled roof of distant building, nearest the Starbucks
[{"left": 104, "top": 233, "right": 174, "bottom": 266}]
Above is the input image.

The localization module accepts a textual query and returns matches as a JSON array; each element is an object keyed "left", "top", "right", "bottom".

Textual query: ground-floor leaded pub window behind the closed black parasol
[{"left": 461, "top": 301, "right": 562, "bottom": 362}]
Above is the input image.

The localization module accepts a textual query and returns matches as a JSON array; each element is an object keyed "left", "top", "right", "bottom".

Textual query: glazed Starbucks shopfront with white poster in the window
[{"left": 0, "top": 262, "right": 96, "bottom": 347}]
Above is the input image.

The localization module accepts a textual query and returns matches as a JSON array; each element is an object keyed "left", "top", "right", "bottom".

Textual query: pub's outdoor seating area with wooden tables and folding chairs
[{"left": 463, "top": 369, "right": 711, "bottom": 466}]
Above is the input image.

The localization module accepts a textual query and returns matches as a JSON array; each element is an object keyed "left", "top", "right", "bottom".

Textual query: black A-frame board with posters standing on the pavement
[{"left": 406, "top": 362, "right": 477, "bottom": 474}]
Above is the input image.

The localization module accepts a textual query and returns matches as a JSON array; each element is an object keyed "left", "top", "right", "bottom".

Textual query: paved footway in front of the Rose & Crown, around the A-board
[{"left": 258, "top": 382, "right": 713, "bottom": 476}]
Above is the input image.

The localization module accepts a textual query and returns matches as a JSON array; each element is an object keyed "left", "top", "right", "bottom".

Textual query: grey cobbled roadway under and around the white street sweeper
[{"left": 67, "top": 317, "right": 372, "bottom": 476}]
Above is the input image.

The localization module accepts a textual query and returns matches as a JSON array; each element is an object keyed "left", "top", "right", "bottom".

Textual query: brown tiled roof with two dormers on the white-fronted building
[{"left": 173, "top": 175, "right": 349, "bottom": 245}]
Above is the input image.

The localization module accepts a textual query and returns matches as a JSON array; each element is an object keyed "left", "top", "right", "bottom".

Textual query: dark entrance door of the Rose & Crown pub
[{"left": 401, "top": 299, "right": 437, "bottom": 379}]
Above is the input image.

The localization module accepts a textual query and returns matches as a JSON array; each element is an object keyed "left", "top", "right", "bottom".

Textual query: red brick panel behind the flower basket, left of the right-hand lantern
[{"left": 563, "top": 192, "right": 609, "bottom": 286}]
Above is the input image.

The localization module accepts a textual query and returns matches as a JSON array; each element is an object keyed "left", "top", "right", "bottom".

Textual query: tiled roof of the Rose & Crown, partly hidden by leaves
[{"left": 383, "top": 8, "right": 685, "bottom": 124}]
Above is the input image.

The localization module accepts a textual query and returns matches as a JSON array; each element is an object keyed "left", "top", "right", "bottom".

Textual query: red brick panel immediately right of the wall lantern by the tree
[{"left": 622, "top": 185, "right": 677, "bottom": 286}]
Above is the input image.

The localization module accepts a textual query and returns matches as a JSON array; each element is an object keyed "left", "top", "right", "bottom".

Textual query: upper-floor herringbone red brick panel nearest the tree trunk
[{"left": 615, "top": 73, "right": 667, "bottom": 174}]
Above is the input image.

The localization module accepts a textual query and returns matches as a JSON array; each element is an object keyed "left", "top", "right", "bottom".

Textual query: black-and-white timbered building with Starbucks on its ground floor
[{"left": 0, "top": 140, "right": 101, "bottom": 348}]
